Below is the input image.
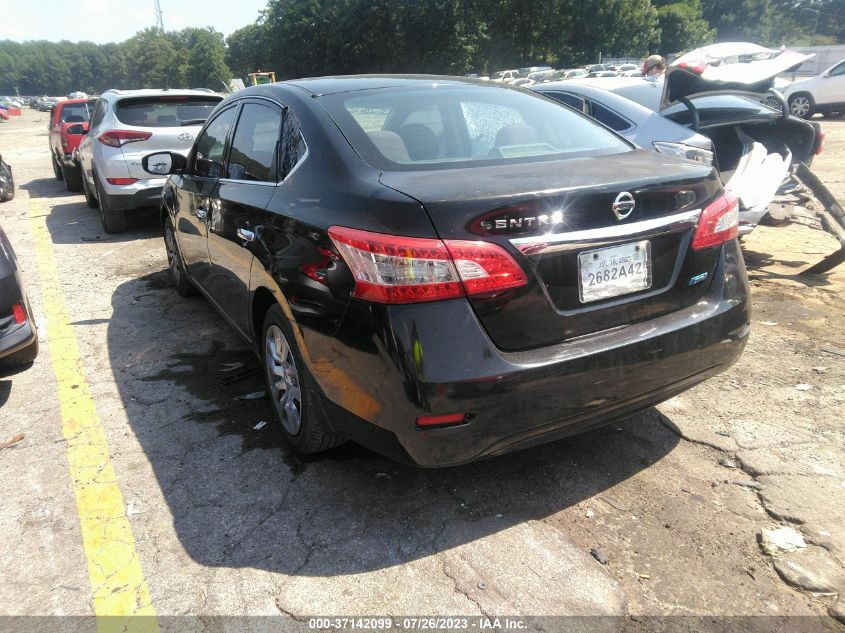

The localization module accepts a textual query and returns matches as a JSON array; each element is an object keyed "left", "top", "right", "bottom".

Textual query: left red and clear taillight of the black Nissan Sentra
[{"left": 329, "top": 226, "right": 528, "bottom": 303}]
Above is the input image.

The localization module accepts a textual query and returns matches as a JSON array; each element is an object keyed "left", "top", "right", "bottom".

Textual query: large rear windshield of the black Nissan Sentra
[{"left": 320, "top": 85, "right": 631, "bottom": 171}]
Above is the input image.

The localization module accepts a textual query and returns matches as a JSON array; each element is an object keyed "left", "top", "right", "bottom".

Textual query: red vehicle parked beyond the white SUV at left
[{"left": 47, "top": 99, "right": 96, "bottom": 191}]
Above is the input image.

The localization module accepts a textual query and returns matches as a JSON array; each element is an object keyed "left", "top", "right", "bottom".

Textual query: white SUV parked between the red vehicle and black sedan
[{"left": 76, "top": 90, "right": 222, "bottom": 233}]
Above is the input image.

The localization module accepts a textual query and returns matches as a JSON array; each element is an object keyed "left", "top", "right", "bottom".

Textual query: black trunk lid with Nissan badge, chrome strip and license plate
[{"left": 380, "top": 150, "right": 720, "bottom": 350}]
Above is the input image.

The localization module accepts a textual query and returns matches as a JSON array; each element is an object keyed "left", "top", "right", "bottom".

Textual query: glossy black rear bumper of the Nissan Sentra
[{"left": 304, "top": 241, "right": 750, "bottom": 466}]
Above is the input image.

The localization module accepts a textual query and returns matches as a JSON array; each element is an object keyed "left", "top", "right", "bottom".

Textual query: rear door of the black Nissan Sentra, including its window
[{"left": 206, "top": 99, "right": 282, "bottom": 335}]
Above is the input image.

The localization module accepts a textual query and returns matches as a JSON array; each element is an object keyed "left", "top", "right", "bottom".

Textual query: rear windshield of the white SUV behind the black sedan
[{"left": 114, "top": 95, "right": 222, "bottom": 127}]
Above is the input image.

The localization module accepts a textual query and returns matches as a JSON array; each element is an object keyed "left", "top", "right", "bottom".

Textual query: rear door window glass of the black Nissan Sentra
[{"left": 227, "top": 103, "right": 282, "bottom": 182}]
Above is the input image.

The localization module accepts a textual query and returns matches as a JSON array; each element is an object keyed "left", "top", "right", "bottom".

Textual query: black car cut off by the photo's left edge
[{"left": 0, "top": 228, "right": 38, "bottom": 370}]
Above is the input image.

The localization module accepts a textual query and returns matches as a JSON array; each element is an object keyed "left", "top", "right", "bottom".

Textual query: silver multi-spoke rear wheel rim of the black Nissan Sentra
[{"left": 264, "top": 325, "right": 302, "bottom": 435}]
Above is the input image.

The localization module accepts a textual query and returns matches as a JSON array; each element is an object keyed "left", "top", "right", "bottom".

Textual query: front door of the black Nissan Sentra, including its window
[{"left": 174, "top": 104, "right": 239, "bottom": 292}]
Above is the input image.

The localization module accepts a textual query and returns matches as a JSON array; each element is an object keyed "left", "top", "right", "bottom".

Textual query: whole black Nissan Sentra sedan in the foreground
[{"left": 143, "top": 76, "right": 749, "bottom": 466}]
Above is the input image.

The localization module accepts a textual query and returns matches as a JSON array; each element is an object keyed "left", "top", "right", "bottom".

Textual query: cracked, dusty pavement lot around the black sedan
[{"left": 0, "top": 110, "right": 845, "bottom": 631}]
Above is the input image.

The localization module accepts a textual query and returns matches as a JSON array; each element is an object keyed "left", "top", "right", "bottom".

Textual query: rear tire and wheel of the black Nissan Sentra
[{"left": 261, "top": 304, "right": 346, "bottom": 454}]
